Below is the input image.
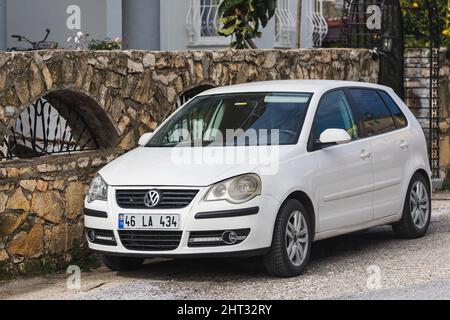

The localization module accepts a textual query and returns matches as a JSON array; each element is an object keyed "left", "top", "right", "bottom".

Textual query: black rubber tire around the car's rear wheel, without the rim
[{"left": 392, "top": 173, "right": 431, "bottom": 239}]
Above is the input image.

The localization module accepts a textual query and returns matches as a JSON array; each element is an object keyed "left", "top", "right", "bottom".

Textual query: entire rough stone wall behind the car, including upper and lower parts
[{"left": 0, "top": 49, "right": 378, "bottom": 274}]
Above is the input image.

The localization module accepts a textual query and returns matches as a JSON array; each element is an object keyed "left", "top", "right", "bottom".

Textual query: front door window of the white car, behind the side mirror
[{"left": 312, "top": 90, "right": 358, "bottom": 140}]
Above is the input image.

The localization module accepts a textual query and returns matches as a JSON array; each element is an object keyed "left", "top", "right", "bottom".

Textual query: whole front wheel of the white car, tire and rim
[{"left": 264, "top": 199, "right": 312, "bottom": 277}]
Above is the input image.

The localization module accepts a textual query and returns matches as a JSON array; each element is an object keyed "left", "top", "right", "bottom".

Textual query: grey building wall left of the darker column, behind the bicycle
[{"left": 6, "top": 0, "right": 122, "bottom": 48}]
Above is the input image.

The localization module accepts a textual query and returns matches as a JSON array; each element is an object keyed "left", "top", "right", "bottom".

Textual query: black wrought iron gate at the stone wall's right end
[{"left": 341, "top": 0, "right": 440, "bottom": 178}]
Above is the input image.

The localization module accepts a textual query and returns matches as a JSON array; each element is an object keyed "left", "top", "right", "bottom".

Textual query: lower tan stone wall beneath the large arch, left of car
[{"left": 0, "top": 150, "right": 121, "bottom": 278}]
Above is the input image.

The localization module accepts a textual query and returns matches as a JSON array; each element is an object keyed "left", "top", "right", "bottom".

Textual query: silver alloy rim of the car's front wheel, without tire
[{"left": 286, "top": 210, "right": 309, "bottom": 267}]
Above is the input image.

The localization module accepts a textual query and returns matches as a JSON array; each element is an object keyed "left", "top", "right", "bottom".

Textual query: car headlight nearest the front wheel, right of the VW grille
[{"left": 204, "top": 173, "right": 261, "bottom": 203}]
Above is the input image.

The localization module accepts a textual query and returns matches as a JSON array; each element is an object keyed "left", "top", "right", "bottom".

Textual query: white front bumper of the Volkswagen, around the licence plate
[{"left": 84, "top": 187, "right": 279, "bottom": 258}]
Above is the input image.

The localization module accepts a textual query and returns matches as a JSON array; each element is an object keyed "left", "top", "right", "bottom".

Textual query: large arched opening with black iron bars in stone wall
[{"left": 0, "top": 90, "right": 119, "bottom": 159}]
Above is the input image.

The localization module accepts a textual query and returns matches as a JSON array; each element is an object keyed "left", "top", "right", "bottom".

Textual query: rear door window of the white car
[{"left": 349, "top": 89, "right": 395, "bottom": 136}]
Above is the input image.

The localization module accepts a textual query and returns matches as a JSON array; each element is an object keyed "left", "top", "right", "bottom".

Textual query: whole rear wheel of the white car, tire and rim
[{"left": 392, "top": 174, "right": 431, "bottom": 239}]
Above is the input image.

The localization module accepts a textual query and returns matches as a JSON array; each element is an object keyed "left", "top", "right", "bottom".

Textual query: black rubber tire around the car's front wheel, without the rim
[{"left": 264, "top": 199, "right": 313, "bottom": 277}]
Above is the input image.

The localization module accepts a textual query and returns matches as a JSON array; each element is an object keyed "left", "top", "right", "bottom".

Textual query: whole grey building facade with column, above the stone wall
[{"left": 0, "top": 0, "right": 311, "bottom": 50}]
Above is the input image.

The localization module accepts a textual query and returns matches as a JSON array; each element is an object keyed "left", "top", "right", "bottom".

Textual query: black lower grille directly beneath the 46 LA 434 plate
[{"left": 119, "top": 230, "right": 183, "bottom": 251}]
